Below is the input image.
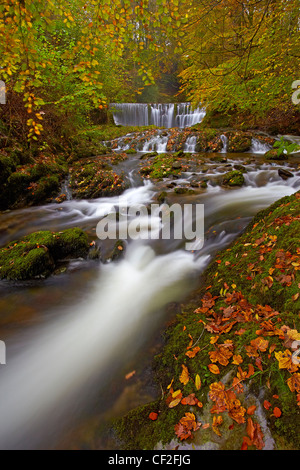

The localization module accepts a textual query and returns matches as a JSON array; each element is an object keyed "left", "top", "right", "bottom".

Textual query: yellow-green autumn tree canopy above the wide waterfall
[{"left": 0, "top": 0, "right": 300, "bottom": 140}]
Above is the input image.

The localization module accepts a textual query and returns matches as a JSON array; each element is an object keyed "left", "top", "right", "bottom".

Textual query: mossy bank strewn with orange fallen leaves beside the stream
[{"left": 115, "top": 192, "right": 300, "bottom": 450}]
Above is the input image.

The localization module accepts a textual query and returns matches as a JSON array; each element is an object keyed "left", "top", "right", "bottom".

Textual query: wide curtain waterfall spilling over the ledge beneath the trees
[{"left": 111, "top": 103, "right": 205, "bottom": 128}]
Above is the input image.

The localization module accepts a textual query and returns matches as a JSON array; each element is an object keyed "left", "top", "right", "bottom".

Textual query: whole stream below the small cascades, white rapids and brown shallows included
[{"left": 0, "top": 145, "right": 300, "bottom": 449}]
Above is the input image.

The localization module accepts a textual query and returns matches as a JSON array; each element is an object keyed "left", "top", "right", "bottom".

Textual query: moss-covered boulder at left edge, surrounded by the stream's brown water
[{"left": 0, "top": 228, "right": 89, "bottom": 280}]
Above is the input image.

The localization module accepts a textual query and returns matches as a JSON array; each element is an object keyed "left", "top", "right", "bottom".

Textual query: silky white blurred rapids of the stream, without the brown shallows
[{"left": 0, "top": 157, "right": 300, "bottom": 449}]
